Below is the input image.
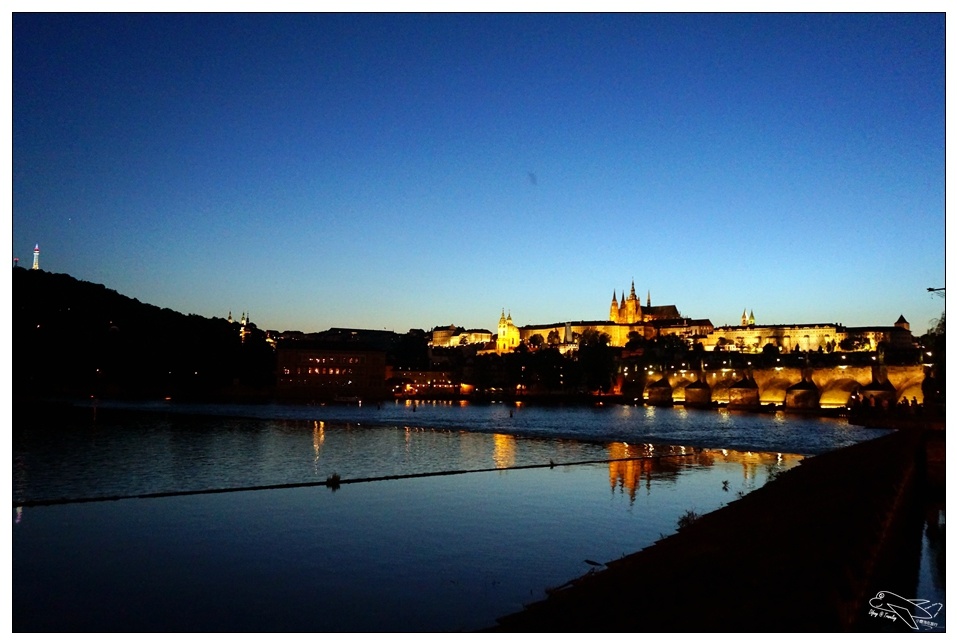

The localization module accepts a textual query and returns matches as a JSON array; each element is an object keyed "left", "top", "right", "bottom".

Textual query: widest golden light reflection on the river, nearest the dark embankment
[{"left": 608, "top": 442, "right": 803, "bottom": 500}]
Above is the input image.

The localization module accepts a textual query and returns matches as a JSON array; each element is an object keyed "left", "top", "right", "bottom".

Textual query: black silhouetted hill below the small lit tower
[{"left": 12, "top": 268, "right": 275, "bottom": 399}]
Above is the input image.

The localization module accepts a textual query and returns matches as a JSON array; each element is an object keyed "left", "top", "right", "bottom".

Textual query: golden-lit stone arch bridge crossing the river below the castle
[{"left": 644, "top": 365, "right": 924, "bottom": 409}]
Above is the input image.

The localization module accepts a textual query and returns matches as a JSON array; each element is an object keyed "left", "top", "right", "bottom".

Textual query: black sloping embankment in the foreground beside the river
[{"left": 495, "top": 430, "right": 944, "bottom": 632}]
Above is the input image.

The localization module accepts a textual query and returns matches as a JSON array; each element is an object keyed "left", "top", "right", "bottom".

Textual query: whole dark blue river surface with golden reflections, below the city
[{"left": 13, "top": 403, "right": 936, "bottom": 632}]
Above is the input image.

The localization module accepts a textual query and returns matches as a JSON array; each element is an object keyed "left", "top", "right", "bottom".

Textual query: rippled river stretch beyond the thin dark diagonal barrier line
[{"left": 12, "top": 402, "right": 871, "bottom": 504}]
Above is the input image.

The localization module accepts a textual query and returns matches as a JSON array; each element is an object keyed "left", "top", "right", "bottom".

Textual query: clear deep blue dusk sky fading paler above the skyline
[{"left": 12, "top": 14, "right": 945, "bottom": 333}]
